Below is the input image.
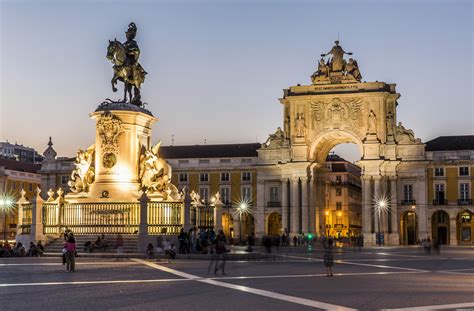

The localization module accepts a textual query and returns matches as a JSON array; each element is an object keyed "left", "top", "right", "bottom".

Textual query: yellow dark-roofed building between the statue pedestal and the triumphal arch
[{"left": 160, "top": 143, "right": 260, "bottom": 236}]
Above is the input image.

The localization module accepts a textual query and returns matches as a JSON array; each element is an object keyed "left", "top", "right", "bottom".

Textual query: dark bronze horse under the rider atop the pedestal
[{"left": 107, "top": 39, "right": 147, "bottom": 106}]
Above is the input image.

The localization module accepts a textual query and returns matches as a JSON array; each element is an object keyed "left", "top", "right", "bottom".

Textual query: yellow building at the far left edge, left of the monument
[{"left": 0, "top": 159, "right": 41, "bottom": 239}]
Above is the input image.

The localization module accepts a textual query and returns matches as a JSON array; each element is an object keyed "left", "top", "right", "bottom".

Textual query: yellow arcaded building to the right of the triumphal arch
[{"left": 424, "top": 135, "right": 474, "bottom": 245}]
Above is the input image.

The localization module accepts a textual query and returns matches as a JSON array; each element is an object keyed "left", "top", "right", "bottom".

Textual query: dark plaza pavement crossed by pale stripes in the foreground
[{"left": 0, "top": 247, "right": 474, "bottom": 311}]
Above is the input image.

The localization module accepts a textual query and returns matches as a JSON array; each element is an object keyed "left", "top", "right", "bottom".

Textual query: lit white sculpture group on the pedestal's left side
[{"left": 68, "top": 145, "right": 95, "bottom": 193}]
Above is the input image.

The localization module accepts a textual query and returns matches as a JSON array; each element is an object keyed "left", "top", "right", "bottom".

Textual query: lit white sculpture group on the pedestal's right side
[{"left": 139, "top": 142, "right": 179, "bottom": 200}]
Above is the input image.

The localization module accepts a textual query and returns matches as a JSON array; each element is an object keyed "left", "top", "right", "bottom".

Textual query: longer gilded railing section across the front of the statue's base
[{"left": 60, "top": 203, "right": 140, "bottom": 234}]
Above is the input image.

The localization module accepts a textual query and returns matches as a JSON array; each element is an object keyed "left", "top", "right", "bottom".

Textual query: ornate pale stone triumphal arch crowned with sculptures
[{"left": 255, "top": 41, "right": 427, "bottom": 245}]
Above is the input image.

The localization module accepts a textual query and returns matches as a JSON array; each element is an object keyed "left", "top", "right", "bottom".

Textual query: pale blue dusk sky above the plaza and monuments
[{"left": 0, "top": 0, "right": 474, "bottom": 161}]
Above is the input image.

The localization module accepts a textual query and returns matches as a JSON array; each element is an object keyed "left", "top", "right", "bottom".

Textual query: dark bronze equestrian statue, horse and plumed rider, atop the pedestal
[{"left": 107, "top": 23, "right": 147, "bottom": 106}]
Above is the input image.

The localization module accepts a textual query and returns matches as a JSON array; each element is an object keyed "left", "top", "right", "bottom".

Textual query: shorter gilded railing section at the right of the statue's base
[{"left": 148, "top": 202, "right": 184, "bottom": 234}]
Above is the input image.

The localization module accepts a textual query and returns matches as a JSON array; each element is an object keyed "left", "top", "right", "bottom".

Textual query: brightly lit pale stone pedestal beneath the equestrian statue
[{"left": 66, "top": 103, "right": 158, "bottom": 202}]
